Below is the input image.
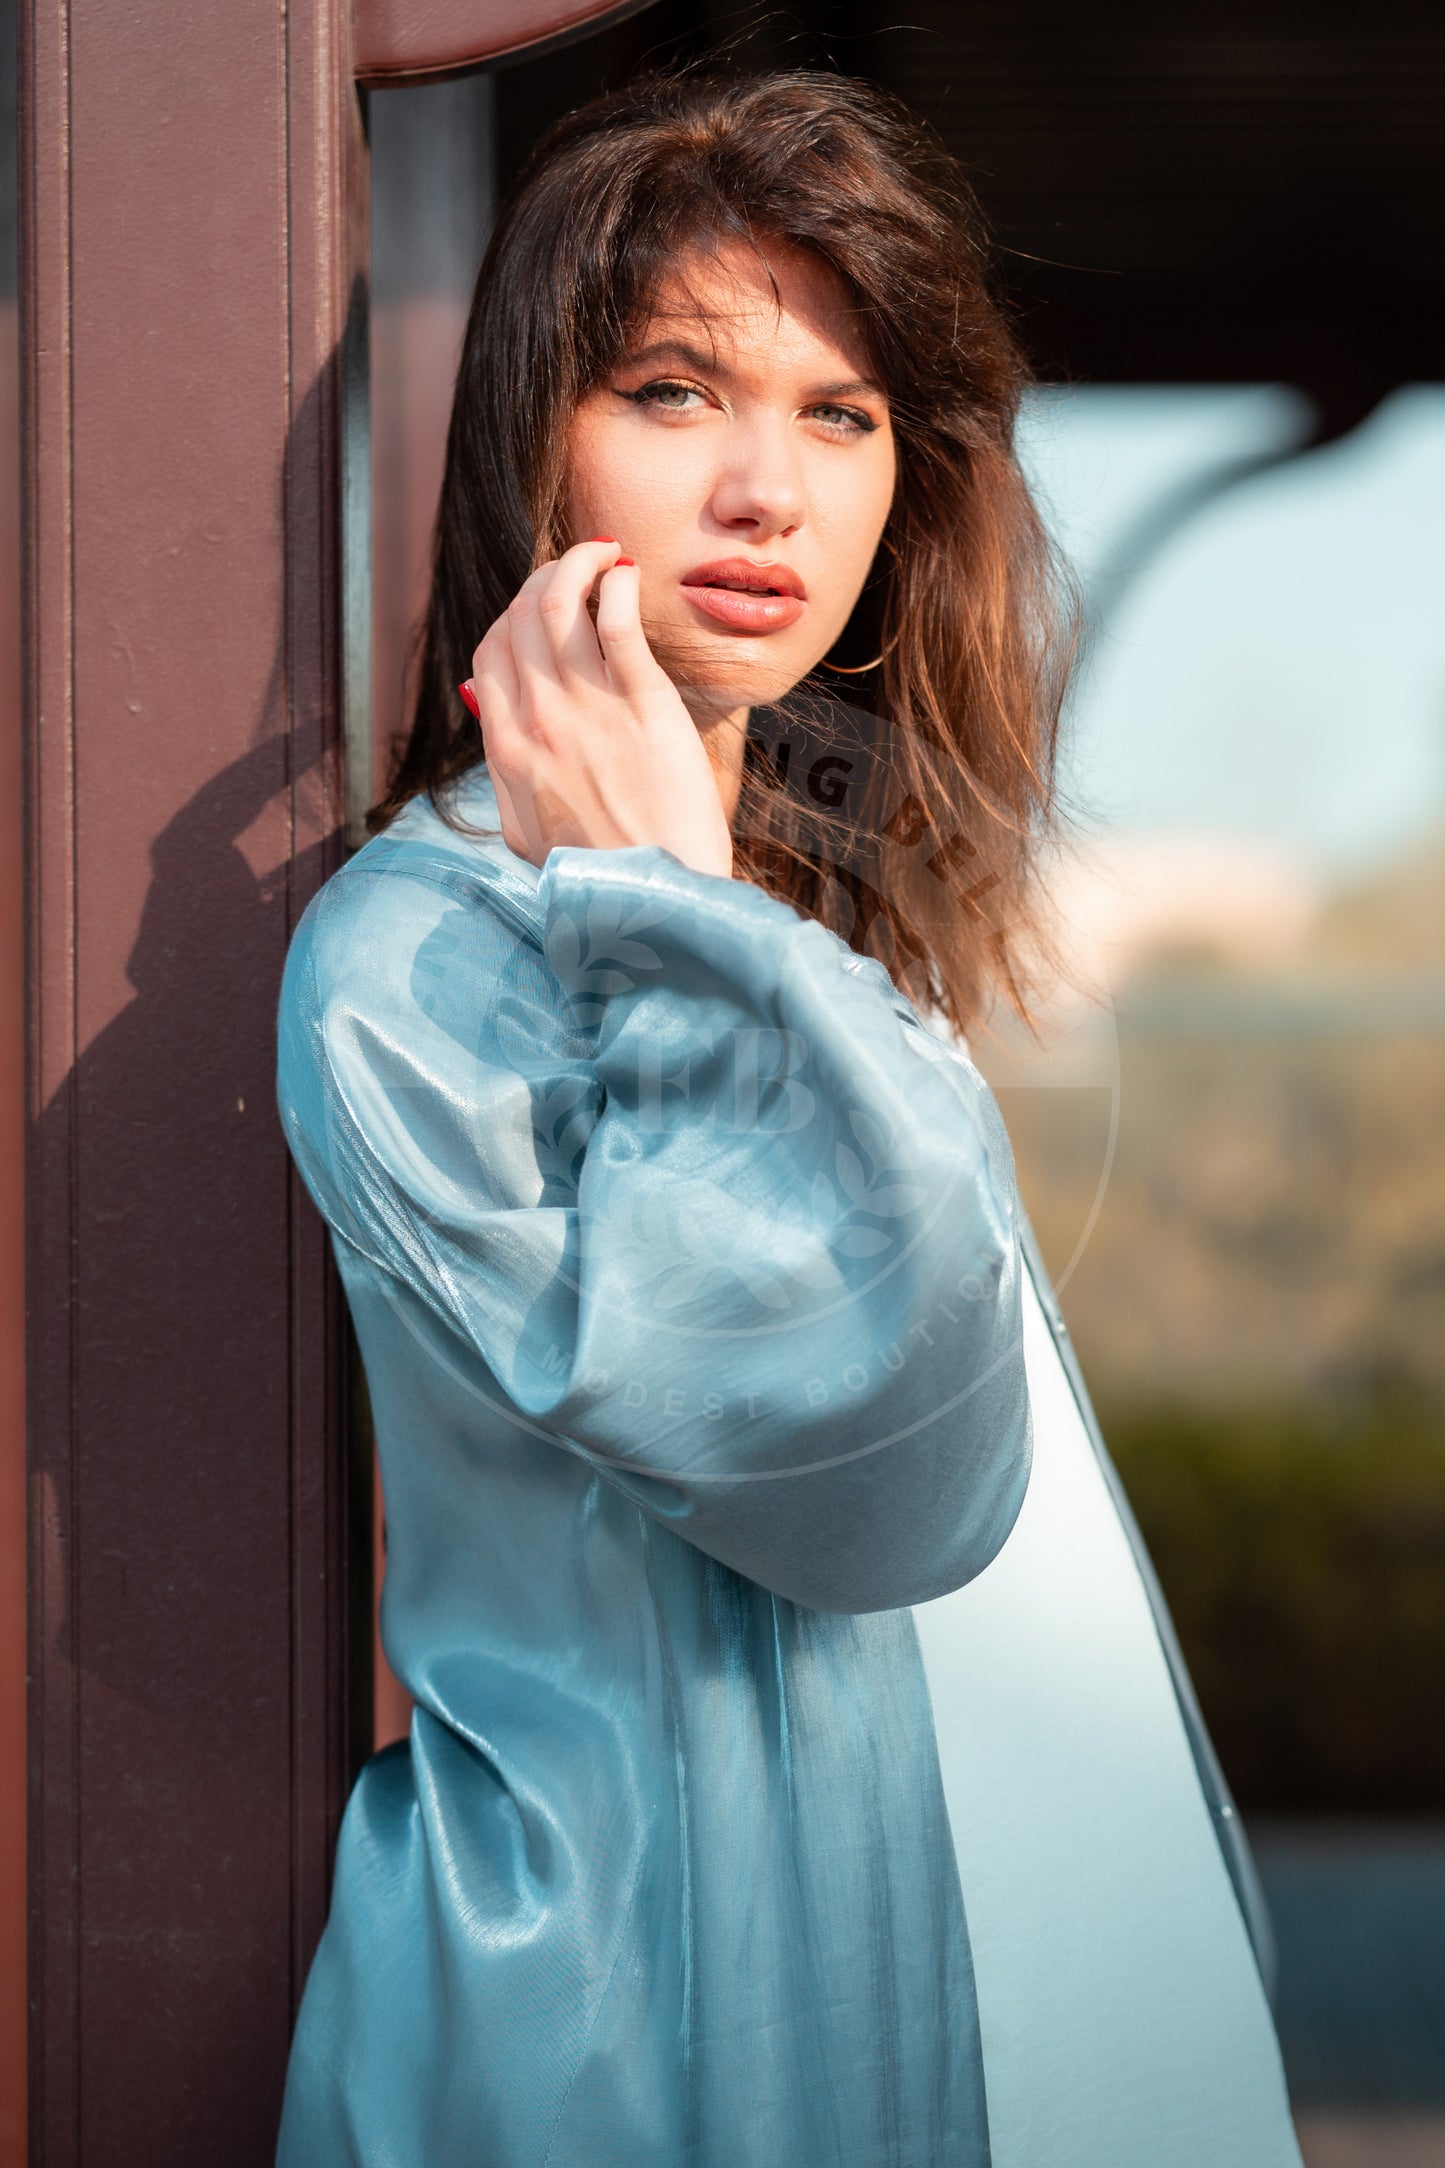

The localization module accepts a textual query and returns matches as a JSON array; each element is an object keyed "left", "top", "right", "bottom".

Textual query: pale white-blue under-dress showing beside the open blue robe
[{"left": 914, "top": 1273, "right": 1300, "bottom": 2168}]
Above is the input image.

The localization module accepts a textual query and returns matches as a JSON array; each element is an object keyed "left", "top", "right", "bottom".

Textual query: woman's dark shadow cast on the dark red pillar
[{"left": 26, "top": 351, "right": 368, "bottom": 2161}]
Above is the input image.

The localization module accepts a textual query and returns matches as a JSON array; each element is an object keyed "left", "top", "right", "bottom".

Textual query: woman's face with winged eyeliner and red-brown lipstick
[{"left": 563, "top": 243, "right": 897, "bottom": 715}]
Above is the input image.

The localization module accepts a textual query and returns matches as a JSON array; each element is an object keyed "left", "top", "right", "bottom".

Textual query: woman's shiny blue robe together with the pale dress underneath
[{"left": 277, "top": 770, "right": 1298, "bottom": 2168}]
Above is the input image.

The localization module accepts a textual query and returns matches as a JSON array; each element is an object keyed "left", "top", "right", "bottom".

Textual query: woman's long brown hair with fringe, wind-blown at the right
[{"left": 370, "top": 67, "right": 1077, "bottom": 1030}]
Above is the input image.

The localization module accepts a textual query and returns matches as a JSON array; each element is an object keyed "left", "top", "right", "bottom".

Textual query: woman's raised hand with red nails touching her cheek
[{"left": 472, "top": 540, "right": 732, "bottom": 876}]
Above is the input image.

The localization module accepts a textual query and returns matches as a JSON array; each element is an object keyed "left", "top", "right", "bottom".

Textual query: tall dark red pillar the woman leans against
[{"left": 22, "top": 0, "right": 654, "bottom": 2168}]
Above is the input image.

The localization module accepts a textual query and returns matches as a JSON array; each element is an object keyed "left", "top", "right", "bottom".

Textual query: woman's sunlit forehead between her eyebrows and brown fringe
[{"left": 630, "top": 241, "right": 871, "bottom": 375}]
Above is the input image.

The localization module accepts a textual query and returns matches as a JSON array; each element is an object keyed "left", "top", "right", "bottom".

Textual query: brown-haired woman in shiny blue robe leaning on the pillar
[{"left": 270, "top": 74, "right": 1298, "bottom": 2168}]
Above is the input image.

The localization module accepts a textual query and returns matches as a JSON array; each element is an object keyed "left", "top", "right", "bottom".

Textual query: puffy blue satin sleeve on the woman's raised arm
[{"left": 279, "top": 846, "right": 1031, "bottom": 1611}]
